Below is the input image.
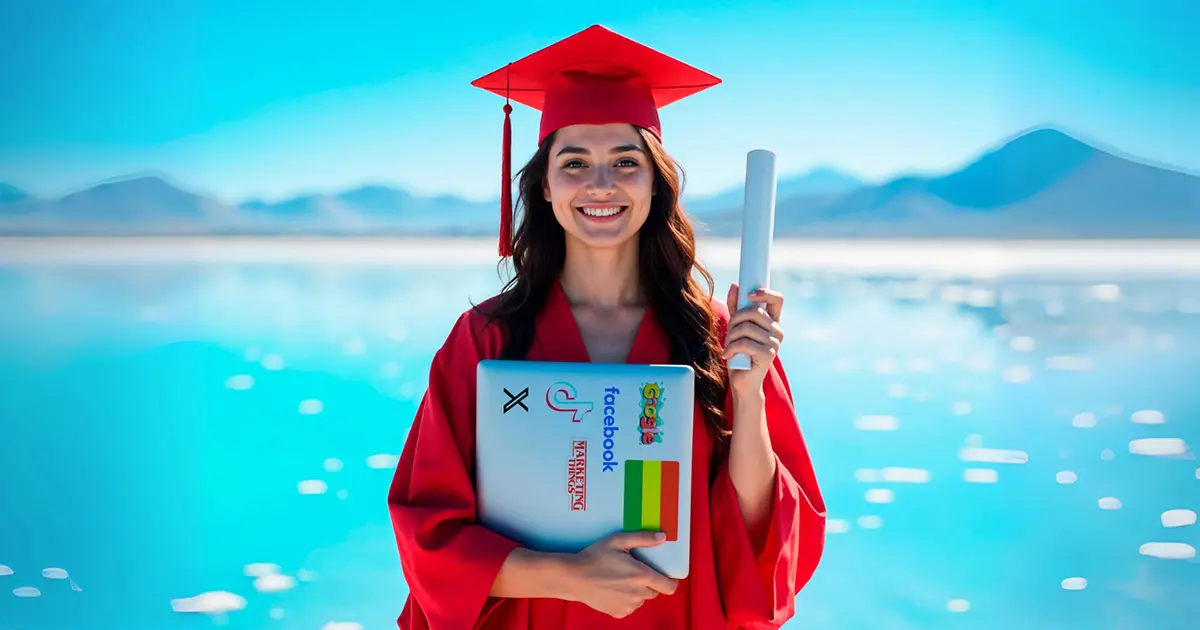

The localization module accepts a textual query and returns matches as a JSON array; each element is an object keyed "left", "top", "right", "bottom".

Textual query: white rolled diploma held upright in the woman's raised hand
[{"left": 730, "top": 149, "right": 776, "bottom": 370}]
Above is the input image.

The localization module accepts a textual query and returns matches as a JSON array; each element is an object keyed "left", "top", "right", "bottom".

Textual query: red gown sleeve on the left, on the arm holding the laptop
[{"left": 388, "top": 313, "right": 517, "bottom": 630}]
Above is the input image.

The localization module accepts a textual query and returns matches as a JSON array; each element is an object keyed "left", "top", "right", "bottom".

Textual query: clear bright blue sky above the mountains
[{"left": 0, "top": 0, "right": 1200, "bottom": 199}]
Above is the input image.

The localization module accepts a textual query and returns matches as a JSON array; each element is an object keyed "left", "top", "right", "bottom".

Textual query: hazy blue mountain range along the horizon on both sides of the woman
[{"left": 0, "top": 127, "right": 1200, "bottom": 239}]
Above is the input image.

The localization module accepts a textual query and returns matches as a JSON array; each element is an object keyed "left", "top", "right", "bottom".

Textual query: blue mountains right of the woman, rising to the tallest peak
[{"left": 703, "top": 128, "right": 1200, "bottom": 239}]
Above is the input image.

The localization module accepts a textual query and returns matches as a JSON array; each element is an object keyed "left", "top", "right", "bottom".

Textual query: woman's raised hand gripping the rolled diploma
[{"left": 722, "top": 282, "right": 784, "bottom": 395}]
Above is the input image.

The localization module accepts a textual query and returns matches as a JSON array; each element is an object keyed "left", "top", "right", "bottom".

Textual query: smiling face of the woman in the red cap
[{"left": 544, "top": 124, "right": 654, "bottom": 247}]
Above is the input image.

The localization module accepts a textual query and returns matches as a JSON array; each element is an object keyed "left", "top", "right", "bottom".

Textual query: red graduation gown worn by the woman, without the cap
[{"left": 388, "top": 282, "right": 826, "bottom": 630}]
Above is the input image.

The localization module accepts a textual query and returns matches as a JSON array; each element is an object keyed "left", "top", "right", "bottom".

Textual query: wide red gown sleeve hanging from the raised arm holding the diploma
[{"left": 710, "top": 356, "right": 826, "bottom": 629}]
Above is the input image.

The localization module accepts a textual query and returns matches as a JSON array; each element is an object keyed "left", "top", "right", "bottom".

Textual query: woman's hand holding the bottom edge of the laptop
[{"left": 559, "top": 532, "right": 678, "bottom": 619}]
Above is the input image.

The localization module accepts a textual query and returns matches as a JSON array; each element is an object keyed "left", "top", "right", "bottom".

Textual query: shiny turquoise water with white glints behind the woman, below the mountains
[{"left": 0, "top": 247, "right": 1200, "bottom": 630}]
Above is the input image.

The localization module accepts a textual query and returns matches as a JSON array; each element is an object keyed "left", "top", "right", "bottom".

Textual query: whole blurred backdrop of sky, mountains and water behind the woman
[{"left": 0, "top": 0, "right": 1200, "bottom": 630}]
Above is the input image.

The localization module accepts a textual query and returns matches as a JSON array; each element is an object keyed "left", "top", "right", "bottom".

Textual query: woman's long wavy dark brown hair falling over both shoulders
[{"left": 485, "top": 128, "right": 730, "bottom": 437}]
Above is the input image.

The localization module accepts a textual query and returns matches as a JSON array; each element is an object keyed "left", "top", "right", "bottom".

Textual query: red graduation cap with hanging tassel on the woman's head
[{"left": 470, "top": 25, "right": 721, "bottom": 256}]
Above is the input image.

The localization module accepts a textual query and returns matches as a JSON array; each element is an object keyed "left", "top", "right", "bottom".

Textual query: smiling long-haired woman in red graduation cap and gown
[{"left": 389, "top": 26, "right": 824, "bottom": 630}]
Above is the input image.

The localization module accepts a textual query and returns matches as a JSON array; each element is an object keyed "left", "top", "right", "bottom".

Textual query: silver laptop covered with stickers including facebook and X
[{"left": 475, "top": 360, "right": 695, "bottom": 578}]
